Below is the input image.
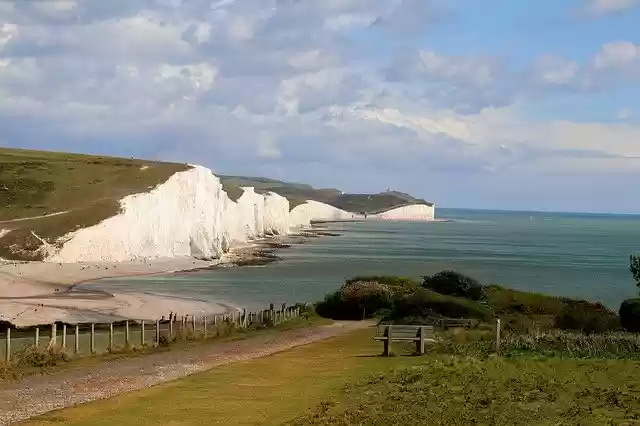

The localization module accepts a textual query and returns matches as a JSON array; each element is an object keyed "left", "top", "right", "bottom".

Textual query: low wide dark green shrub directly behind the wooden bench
[{"left": 392, "top": 289, "right": 491, "bottom": 319}]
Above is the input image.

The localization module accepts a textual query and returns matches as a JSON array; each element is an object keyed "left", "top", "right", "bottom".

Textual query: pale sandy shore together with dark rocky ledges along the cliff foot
[{"left": 0, "top": 226, "right": 340, "bottom": 327}]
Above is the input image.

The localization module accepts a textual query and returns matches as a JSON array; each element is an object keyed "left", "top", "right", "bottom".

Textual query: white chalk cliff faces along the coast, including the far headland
[{"left": 46, "top": 166, "right": 433, "bottom": 263}]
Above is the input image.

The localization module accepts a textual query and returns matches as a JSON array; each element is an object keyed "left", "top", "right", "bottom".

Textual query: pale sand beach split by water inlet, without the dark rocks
[{"left": 0, "top": 258, "right": 234, "bottom": 327}]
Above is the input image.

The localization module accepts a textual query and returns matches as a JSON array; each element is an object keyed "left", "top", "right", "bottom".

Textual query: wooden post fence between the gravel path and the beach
[{"left": 0, "top": 304, "right": 300, "bottom": 363}]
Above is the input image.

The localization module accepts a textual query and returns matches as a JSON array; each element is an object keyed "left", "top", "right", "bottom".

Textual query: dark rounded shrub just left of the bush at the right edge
[{"left": 555, "top": 300, "right": 620, "bottom": 333}]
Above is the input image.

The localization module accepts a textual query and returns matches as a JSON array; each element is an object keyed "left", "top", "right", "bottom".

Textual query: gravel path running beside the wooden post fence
[{"left": 0, "top": 321, "right": 371, "bottom": 425}]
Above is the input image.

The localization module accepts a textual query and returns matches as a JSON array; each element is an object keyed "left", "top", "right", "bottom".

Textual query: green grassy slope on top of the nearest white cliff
[{"left": 0, "top": 148, "right": 188, "bottom": 259}]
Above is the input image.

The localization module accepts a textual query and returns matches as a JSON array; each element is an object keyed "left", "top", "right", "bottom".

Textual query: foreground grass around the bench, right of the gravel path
[{"left": 26, "top": 330, "right": 640, "bottom": 425}]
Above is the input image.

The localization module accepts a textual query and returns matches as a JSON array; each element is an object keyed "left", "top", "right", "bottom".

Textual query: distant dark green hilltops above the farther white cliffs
[{"left": 220, "top": 176, "right": 433, "bottom": 214}]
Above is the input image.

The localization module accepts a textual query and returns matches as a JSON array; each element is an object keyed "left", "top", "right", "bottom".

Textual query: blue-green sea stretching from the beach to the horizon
[{"left": 81, "top": 209, "right": 640, "bottom": 309}]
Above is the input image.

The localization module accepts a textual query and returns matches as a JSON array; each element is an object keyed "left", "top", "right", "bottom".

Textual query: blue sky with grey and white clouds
[{"left": 0, "top": 0, "right": 640, "bottom": 213}]
